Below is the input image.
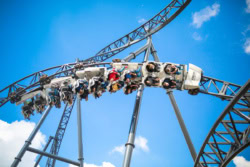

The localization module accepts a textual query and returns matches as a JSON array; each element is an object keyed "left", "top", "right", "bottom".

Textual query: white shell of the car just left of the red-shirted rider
[{"left": 76, "top": 67, "right": 107, "bottom": 80}]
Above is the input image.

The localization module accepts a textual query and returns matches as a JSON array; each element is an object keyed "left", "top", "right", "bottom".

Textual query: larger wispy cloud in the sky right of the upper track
[{"left": 192, "top": 3, "right": 220, "bottom": 28}]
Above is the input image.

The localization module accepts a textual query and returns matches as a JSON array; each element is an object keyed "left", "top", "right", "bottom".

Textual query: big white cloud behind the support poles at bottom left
[{"left": 0, "top": 120, "right": 46, "bottom": 167}]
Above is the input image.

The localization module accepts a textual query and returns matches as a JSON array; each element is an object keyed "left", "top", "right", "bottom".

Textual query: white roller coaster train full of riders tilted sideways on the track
[{"left": 13, "top": 62, "right": 202, "bottom": 113}]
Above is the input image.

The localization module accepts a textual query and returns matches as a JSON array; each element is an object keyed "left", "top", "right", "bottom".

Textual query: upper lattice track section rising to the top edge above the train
[{"left": 83, "top": 0, "right": 191, "bottom": 63}]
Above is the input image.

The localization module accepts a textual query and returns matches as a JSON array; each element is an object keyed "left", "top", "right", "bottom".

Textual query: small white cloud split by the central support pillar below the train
[{"left": 110, "top": 136, "right": 149, "bottom": 155}]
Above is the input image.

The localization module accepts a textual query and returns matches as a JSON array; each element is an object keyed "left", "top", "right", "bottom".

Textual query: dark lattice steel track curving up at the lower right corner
[{"left": 194, "top": 80, "right": 250, "bottom": 167}]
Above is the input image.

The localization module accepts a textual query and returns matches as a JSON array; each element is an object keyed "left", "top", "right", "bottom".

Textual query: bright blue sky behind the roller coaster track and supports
[{"left": 0, "top": 0, "right": 250, "bottom": 167}]
